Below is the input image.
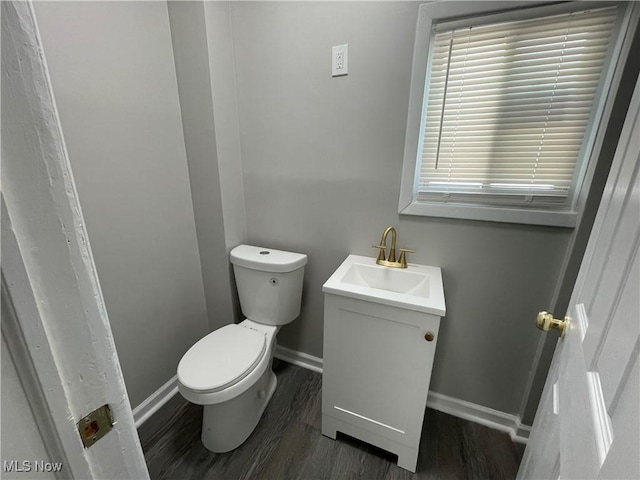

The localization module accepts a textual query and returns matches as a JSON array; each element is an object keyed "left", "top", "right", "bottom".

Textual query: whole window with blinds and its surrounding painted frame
[{"left": 400, "top": 2, "right": 636, "bottom": 226}]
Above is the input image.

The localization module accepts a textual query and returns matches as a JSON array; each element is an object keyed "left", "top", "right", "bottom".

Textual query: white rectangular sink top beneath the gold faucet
[{"left": 322, "top": 255, "right": 446, "bottom": 316}]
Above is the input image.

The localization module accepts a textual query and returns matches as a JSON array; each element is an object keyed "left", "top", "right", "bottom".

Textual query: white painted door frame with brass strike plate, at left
[{"left": 0, "top": 1, "right": 149, "bottom": 479}]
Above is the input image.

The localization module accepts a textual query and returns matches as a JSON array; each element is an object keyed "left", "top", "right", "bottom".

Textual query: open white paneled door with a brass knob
[{"left": 518, "top": 77, "right": 640, "bottom": 480}]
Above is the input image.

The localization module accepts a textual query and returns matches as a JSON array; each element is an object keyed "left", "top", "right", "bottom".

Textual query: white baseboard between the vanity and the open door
[{"left": 427, "top": 391, "right": 531, "bottom": 443}]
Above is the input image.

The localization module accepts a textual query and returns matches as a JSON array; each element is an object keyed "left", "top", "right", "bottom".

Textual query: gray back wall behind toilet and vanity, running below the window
[{"left": 231, "top": 2, "right": 571, "bottom": 414}]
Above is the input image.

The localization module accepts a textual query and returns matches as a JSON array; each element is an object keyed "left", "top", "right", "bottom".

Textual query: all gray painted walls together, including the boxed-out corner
[{"left": 28, "top": 2, "right": 608, "bottom": 420}]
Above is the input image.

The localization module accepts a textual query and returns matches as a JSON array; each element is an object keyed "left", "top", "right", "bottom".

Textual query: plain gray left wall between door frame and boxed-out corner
[{"left": 35, "top": 2, "right": 208, "bottom": 407}]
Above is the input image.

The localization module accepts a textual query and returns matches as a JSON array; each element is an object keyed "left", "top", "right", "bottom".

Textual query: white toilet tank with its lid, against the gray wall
[{"left": 231, "top": 245, "right": 307, "bottom": 325}]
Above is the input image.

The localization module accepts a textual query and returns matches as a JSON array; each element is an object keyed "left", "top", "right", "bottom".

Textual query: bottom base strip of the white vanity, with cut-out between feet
[{"left": 322, "top": 413, "right": 418, "bottom": 473}]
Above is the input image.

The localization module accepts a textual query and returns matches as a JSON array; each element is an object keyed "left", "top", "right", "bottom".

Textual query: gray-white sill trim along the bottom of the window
[{"left": 399, "top": 202, "right": 578, "bottom": 228}]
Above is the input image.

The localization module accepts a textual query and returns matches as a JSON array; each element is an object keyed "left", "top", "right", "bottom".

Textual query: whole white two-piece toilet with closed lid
[{"left": 178, "top": 245, "right": 307, "bottom": 453}]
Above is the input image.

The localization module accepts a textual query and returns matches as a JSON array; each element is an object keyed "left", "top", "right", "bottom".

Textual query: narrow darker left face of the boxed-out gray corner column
[{"left": 168, "top": 2, "right": 235, "bottom": 330}]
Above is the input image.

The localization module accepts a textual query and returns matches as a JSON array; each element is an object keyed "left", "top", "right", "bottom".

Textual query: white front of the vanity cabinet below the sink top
[{"left": 322, "top": 294, "right": 440, "bottom": 472}]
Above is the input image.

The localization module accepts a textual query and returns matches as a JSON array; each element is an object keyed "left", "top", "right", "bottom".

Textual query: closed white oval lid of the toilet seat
[{"left": 178, "top": 324, "right": 266, "bottom": 391}]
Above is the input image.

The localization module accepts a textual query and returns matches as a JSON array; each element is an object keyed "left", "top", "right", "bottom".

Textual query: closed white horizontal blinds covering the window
[{"left": 418, "top": 7, "right": 617, "bottom": 208}]
